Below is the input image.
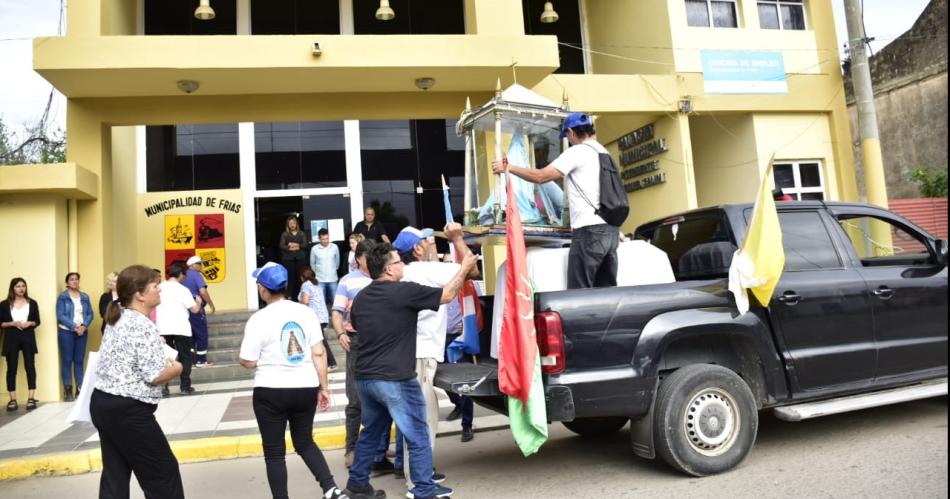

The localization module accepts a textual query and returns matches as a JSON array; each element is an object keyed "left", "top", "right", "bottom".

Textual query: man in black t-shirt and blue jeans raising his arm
[{"left": 344, "top": 243, "right": 476, "bottom": 498}]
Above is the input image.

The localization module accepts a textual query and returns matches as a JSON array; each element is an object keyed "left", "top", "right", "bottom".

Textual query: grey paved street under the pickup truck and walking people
[{"left": 0, "top": 397, "right": 948, "bottom": 499}]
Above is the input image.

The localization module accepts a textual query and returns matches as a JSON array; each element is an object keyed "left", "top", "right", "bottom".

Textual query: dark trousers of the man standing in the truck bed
[{"left": 567, "top": 224, "right": 620, "bottom": 289}]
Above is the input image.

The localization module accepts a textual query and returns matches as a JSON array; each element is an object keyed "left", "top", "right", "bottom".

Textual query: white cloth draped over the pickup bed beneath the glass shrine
[{"left": 491, "top": 241, "right": 676, "bottom": 359}]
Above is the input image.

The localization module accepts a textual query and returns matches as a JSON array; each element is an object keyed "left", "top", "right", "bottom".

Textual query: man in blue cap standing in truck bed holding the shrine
[{"left": 492, "top": 113, "right": 620, "bottom": 289}]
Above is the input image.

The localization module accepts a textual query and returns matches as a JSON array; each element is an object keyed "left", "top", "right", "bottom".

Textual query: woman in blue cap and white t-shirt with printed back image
[{"left": 240, "top": 262, "right": 346, "bottom": 499}]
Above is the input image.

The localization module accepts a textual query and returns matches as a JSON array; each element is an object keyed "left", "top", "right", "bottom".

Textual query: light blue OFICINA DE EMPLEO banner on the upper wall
[{"left": 701, "top": 50, "right": 788, "bottom": 94}]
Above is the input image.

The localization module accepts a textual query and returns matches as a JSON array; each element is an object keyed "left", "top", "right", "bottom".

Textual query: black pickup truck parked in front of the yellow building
[{"left": 435, "top": 201, "right": 947, "bottom": 476}]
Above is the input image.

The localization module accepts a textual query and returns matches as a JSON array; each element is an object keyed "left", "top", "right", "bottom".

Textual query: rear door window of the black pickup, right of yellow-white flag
[{"left": 776, "top": 210, "right": 841, "bottom": 271}]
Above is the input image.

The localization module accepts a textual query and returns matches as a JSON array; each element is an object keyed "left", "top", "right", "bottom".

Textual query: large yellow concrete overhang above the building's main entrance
[{"left": 33, "top": 35, "right": 559, "bottom": 98}]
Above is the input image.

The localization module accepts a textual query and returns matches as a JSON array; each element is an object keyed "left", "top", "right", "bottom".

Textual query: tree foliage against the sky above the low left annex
[{"left": 0, "top": 119, "right": 66, "bottom": 165}]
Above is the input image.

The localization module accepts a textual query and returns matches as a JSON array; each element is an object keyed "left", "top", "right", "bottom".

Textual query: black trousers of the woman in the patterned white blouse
[{"left": 89, "top": 390, "right": 185, "bottom": 499}]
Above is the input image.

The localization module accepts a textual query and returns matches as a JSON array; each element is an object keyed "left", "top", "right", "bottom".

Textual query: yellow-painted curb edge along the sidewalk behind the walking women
[{"left": 0, "top": 426, "right": 346, "bottom": 481}]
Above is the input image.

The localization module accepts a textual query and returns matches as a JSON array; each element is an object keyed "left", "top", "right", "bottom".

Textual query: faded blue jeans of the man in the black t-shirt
[{"left": 347, "top": 378, "right": 435, "bottom": 497}]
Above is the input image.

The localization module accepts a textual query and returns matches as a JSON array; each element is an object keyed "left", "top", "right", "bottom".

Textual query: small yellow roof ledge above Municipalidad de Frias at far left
[{"left": 0, "top": 163, "right": 99, "bottom": 200}]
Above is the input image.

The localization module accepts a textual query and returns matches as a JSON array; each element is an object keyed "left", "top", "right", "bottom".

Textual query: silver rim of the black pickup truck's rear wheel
[{"left": 683, "top": 388, "right": 741, "bottom": 456}]
